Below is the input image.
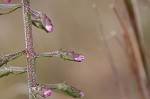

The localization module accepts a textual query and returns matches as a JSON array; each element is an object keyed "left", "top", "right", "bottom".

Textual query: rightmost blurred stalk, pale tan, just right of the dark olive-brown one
[{"left": 129, "top": 0, "right": 150, "bottom": 85}]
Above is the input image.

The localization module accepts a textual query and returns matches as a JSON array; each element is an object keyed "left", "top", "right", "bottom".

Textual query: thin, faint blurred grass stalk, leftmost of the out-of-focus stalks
[{"left": 94, "top": 5, "right": 127, "bottom": 99}]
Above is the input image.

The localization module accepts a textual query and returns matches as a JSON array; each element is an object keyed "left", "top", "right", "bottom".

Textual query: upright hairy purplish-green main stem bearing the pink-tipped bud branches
[{"left": 23, "top": 0, "right": 36, "bottom": 99}]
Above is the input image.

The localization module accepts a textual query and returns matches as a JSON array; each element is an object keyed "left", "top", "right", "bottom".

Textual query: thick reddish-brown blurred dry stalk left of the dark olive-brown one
[{"left": 113, "top": 0, "right": 149, "bottom": 99}]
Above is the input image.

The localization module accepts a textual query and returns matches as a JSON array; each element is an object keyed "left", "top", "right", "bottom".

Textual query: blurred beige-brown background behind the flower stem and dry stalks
[{"left": 0, "top": 0, "right": 150, "bottom": 99}]
